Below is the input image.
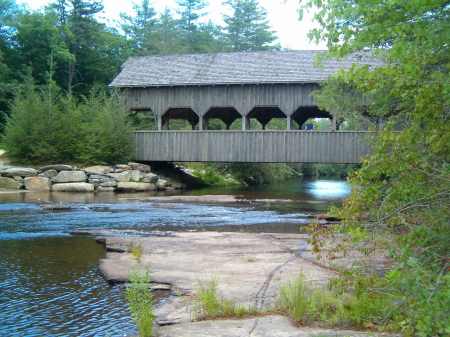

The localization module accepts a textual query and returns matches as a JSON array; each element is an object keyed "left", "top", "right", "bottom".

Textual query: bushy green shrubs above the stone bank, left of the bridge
[{"left": 2, "top": 74, "right": 131, "bottom": 164}]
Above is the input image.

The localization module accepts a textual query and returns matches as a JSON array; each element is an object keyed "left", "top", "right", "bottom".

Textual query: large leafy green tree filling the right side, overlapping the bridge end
[{"left": 303, "top": 0, "right": 450, "bottom": 336}]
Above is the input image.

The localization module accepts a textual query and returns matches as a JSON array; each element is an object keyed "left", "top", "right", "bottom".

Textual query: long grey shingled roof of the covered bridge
[{"left": 110, "top": 50, "right": 380, "bottom": 87}]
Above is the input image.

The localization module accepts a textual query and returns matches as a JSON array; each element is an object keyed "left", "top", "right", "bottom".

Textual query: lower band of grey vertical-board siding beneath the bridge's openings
[{"left": 133, "top": 131, "right": 369, "bottom": 163}]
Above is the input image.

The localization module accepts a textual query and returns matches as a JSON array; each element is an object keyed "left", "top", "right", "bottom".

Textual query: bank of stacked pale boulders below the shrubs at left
[{"left": 0, "top": 162, "right": 189, "bottom": 192}]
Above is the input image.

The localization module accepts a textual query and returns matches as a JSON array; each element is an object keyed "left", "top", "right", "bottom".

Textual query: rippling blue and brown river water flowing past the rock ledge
[{"left": 0, "top": 180, "right": 349, "bottom": 336}]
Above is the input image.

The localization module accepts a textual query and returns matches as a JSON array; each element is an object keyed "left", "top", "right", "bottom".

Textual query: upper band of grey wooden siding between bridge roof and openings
[{"left": 127, "top": 83, "right": 318, "bottom": 117}]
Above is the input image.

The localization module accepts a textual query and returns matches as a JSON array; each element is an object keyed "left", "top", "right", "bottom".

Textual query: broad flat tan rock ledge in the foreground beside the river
[{"left": 96, "top": 232, "right": 394, "bottom": 337}]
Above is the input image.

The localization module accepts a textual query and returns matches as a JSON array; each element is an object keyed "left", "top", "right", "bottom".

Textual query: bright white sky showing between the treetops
[{"left": 16, "top": 0, "right": 326, "bottom": 50}]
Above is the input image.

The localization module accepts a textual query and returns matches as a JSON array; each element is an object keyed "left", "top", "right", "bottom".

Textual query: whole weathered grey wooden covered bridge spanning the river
[{"left": 110, "top": 50, "right": 380, "bottom": 163}]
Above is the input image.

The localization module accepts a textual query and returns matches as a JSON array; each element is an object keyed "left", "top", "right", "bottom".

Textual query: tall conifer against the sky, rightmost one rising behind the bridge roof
[{"left": 223, "top": 0, "right": 277, "bottom": 51}]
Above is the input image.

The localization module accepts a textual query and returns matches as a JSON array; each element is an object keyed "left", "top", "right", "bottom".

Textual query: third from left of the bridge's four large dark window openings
[{"left": 247, "top": 107, "right": 287, "bottom": 130}]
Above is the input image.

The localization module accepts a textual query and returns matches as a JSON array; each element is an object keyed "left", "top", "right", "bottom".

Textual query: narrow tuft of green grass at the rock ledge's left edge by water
[{"left": 126, "top": 265, "right": 155, "bottom": 337}]
